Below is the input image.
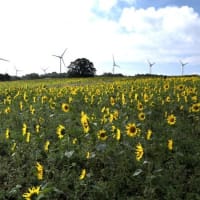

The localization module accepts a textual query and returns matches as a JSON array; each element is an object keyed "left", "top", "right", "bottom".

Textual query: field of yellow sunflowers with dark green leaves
[{"left": 0, "top": 77, "right": 200, "bottom": 200}]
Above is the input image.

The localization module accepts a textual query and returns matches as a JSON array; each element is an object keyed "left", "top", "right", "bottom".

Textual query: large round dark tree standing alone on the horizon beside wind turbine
[{"left": 67, "top": 58, "right": 96, "bottom": 77}]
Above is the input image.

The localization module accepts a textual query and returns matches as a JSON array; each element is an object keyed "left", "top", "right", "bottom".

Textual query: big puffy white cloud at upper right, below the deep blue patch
[{"left": 119, "top": 6, "right": 200, "bottom": 61}]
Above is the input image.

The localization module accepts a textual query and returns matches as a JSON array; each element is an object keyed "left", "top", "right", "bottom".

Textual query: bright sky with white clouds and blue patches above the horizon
[{"left": 0, "top": 0, "right": 200, "bottom": 76}]
